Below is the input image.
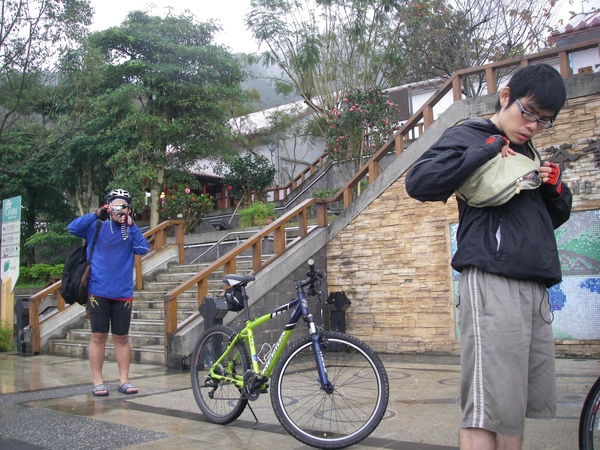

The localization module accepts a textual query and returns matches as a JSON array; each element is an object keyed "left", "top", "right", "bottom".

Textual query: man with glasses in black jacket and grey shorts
[{"left": 406, "top": 64, "right": 572, "bottom": 450}]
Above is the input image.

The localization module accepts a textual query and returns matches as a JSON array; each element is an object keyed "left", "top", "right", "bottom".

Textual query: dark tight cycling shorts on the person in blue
[{"left": 87, "top": 295, "right": 132, "bottom": 336}]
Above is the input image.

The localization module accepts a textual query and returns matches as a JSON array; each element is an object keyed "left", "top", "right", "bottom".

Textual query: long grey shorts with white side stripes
[{"left": 458, "top": 267, "right": 556, "bottom": 435}]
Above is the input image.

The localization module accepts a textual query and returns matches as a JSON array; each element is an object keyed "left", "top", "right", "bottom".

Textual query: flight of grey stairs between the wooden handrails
[{"left": 49, "top": 258, "right": 252, "bottom": 365}]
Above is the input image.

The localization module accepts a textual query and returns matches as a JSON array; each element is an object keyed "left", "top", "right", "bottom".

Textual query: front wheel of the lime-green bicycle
[{"left": 271, "top": 332, "right": 389, "bottom": 448}]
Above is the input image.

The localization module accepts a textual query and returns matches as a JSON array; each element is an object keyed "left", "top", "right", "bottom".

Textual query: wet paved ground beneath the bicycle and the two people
[{"left": 0, "top": 353, "right": 600, "bottom": 450}]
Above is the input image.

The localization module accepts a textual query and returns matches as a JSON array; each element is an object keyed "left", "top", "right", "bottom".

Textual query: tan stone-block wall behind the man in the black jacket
[{"left": 327, "top": 95, "right": 600, "bottom": 356}]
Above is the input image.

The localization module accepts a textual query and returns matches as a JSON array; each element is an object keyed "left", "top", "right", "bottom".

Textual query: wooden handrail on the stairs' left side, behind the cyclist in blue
[{"left": 29, "top": 220, "right": 185, "bottom": 354}]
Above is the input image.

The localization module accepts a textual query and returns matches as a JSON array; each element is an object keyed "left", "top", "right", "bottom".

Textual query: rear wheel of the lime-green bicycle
[{"left": 190, "top": 325, "right": 251, "bottom": 424}]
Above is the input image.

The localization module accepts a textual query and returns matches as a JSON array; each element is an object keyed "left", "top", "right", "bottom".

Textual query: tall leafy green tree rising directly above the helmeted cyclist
[{"left": 90, "top": 11, "right": 244, "bottom": 226}]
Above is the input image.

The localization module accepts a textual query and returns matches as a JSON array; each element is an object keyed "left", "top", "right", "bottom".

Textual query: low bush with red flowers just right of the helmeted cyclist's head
[{"left": 160, "top": 187, "right": 214, "bottom": 234}]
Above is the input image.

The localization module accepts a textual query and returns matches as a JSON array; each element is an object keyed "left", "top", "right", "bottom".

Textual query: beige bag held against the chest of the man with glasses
[{"left": 456, "top": 152, "right": 542, "bottom": 208}]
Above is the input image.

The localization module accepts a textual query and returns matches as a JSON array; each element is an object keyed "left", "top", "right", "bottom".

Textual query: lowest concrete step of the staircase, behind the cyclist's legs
[{"left": 50, "top": 337, "right": 165, "bottom": 365}]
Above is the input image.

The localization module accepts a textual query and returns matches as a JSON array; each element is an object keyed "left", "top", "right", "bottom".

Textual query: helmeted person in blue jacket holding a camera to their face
[{"left": 67, "top": 189, "right": 149, "bottom": 396}]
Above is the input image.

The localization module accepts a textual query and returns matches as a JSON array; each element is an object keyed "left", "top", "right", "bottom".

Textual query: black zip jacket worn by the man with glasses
[{"left": 405, "top": 119, "right": 572, "bottom": 287}]
